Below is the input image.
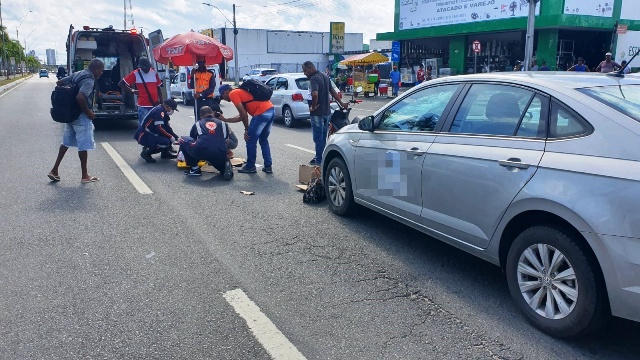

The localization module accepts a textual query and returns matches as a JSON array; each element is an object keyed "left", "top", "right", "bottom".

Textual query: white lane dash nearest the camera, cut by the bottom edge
[{"left": 223, "top": 289, "right": 306, "bottom": 360}]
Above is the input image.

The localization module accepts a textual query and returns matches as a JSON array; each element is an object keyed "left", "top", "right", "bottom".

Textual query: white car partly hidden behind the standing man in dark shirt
[{"left": 266, "top": 73, "right": 342, "bottom": 127}]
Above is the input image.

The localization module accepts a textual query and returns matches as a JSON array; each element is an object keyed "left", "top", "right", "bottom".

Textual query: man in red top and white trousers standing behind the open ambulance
[{"left": 118, "top": 57, "right": 162, "bottom": 126}]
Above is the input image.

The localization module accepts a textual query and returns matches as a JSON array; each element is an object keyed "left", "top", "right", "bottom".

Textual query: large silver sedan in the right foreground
[{"left": 322, "top": 72, "right": 640, "bottom": 337}]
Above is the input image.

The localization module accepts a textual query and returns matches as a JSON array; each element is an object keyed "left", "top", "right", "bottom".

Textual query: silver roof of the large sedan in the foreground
[{"left": 427, "top": 71, "right": 640, "bottom": 91}]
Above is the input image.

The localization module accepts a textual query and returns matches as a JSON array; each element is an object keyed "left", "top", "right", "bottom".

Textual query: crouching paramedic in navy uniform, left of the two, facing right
[{"left": 133, "top": 99, "right": 179, "bottom": 163}]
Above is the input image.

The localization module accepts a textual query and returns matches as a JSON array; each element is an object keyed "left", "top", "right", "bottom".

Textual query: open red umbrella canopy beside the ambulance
[{"left": 153, "top": 31, "right": 233, "bottom": 66}]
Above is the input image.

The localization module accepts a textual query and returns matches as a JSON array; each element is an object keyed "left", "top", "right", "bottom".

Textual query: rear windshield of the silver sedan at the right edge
[{"left": 578, "top": 85, "right": 640, "bottom": 121}]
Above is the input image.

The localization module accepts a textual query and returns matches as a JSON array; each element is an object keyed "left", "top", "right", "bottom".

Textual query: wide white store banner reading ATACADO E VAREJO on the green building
[{"left": 398, "top": 0, "right": 540, "bottom": 30}]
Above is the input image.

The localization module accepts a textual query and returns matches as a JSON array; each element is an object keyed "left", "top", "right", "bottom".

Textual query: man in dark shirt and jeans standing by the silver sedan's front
[{"left": 302, "top": 61, "right": 347, "bottom": 165}]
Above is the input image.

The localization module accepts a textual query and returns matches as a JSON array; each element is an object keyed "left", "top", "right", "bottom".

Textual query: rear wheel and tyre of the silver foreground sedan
[{"left": 506, "top": 226, "right": 609, "bottom": 337}]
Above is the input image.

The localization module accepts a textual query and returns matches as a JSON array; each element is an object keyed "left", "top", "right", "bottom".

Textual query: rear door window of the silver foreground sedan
[{"left": 450, "top": 84, "right": 539, "bottom": 136}]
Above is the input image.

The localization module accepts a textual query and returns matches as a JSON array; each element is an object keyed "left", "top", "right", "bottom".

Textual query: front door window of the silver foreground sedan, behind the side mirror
[{"left": 378, "top": 85, "right": 458, "bottom": 132}]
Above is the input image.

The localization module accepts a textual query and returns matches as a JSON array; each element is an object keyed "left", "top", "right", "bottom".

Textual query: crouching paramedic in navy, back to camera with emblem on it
[{"left": 180, "top": 106, "right": 233, "bottom": 180}]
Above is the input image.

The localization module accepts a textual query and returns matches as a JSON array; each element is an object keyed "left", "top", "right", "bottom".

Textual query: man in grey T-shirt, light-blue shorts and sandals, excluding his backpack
[{"left": 47, "top": 59, "right": 104, "bottom": 184}]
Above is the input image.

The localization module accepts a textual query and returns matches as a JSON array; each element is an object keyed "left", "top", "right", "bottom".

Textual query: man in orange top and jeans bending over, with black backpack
[{"left": 219, "top": 80, "right": 275, "bottom": 174}]
